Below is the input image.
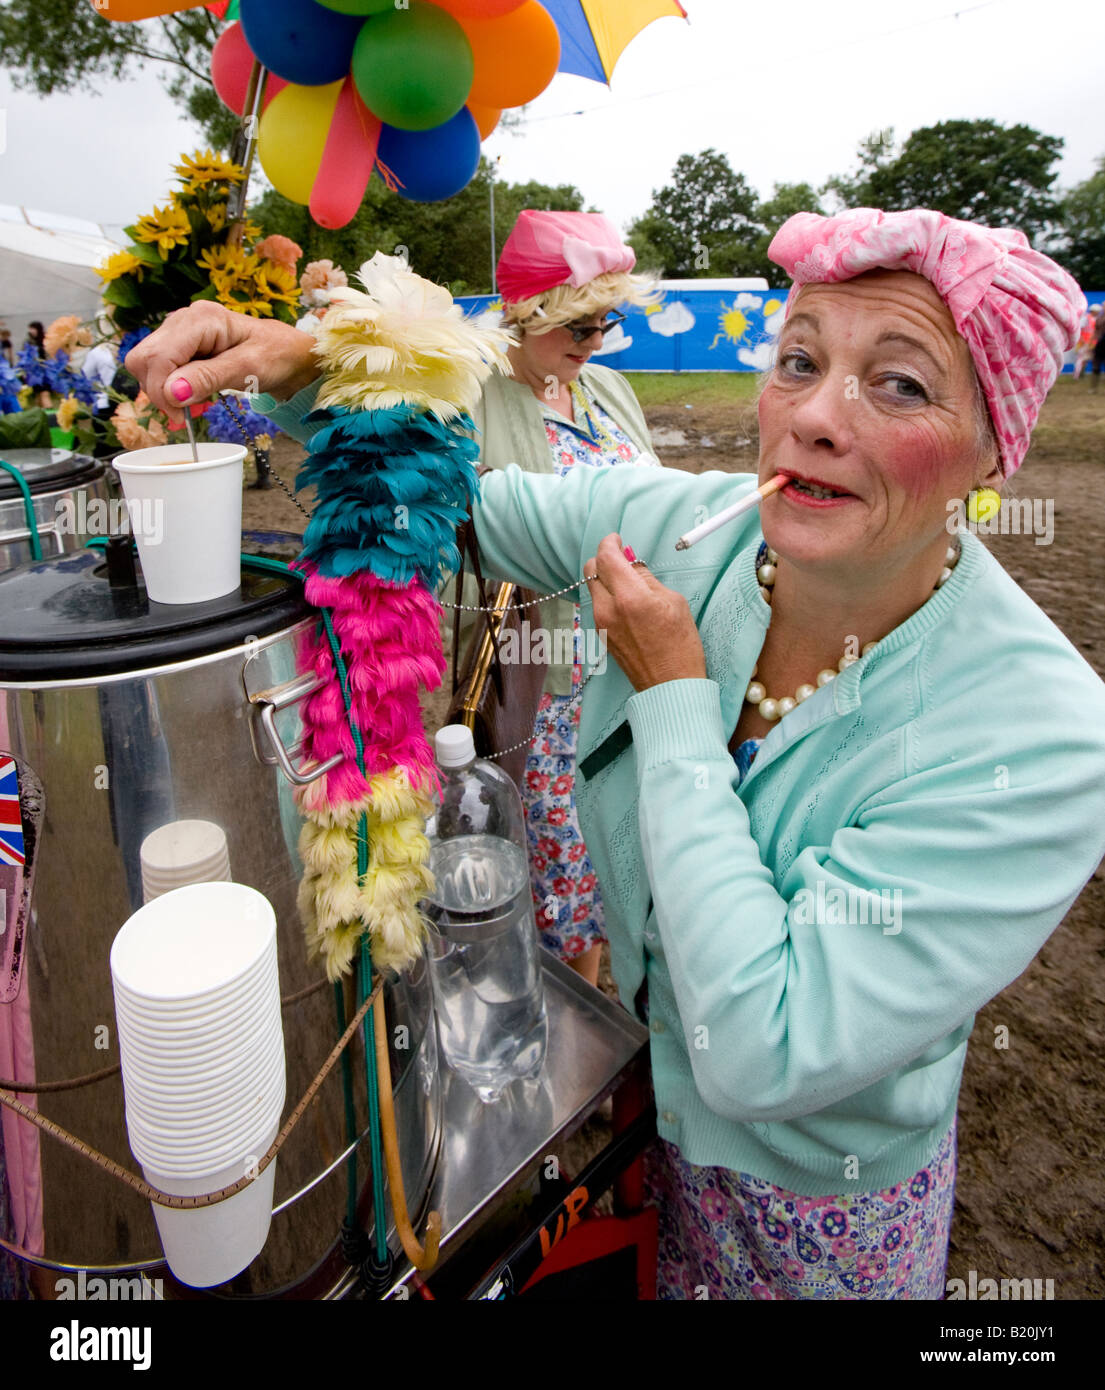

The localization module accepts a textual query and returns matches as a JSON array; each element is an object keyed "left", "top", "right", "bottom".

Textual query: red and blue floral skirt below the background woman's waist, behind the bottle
[{"left": 521, "top": 689, "right": 606, "bottom": 960}]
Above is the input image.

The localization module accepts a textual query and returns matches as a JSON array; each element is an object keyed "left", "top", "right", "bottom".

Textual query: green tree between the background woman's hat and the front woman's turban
[{"left": 628, "top": 150, "right": 763, "bottom": 279}]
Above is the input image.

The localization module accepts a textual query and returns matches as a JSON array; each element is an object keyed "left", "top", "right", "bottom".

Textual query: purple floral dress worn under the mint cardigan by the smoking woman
[{"left": 641, "top": 738, "right": 956, "bottom": 1302}]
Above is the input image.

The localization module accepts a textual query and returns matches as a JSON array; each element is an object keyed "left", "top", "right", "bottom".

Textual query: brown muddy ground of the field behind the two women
[{"left": 250, "top": 379, "right": 1105, "bottom": 1300}]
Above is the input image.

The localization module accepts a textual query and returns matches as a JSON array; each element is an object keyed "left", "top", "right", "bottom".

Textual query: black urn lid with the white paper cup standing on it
[{"left": 0, "top": 531, "right": 314, "bottom": 684}]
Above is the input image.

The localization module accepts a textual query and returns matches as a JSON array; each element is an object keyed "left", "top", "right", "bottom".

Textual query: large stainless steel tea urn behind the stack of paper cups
[{"left": 0, "top": 535, "right": 441, "bottom": 1298}]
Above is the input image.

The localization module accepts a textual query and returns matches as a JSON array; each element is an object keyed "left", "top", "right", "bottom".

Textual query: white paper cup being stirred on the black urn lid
[{"left": 113, "top": 443, "right": 246, "bottom": 603}]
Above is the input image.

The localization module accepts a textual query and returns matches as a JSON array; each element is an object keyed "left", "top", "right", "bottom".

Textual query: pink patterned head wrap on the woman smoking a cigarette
[{"left": 767, "top": 207, "right": 1086, "bottom": 478}]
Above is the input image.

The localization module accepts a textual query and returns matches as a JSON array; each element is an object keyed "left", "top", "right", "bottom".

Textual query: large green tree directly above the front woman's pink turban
[{"left": 827, "top": 120, "right": 1063, "bottom": 240}]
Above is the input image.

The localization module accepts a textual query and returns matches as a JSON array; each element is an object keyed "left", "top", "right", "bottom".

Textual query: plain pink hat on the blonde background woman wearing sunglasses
[{"left": 496, "top": 210, "right": 637, "bottom": 303}]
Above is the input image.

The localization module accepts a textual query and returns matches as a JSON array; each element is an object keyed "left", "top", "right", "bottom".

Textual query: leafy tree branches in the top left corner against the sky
[{"left": 0, "top": 0, "right": 238, "bottom": 149}]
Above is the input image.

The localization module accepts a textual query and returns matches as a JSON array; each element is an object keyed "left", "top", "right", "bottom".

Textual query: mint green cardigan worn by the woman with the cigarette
[{"left": 270, "top": 400, "right": 1105, "bottom": 1195}]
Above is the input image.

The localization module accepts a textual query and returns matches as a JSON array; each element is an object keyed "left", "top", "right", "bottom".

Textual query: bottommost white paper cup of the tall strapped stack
[{"left": 142, "top": 1125, "right": 277, "bottom": 1289}]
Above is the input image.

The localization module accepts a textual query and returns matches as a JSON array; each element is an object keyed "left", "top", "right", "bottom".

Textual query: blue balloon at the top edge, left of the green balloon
[{"left": 239, "top": 0, "right": 366, "bottom": 86}]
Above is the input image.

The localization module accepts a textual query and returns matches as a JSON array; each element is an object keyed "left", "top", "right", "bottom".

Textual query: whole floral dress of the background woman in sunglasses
[{"left": 523, "top": 382, "right": 659, "bottom": 960}]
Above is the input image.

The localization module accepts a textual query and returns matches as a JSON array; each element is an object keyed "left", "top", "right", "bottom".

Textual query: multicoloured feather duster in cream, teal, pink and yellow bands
[{"left": 289, "top": 256, "right": 509, "bottom": 980}]
